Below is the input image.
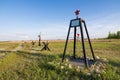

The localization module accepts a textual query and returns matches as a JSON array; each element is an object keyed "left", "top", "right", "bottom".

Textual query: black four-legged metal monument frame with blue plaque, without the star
[{"left": 62, "top": 18, "right": 95, "bottom": 68}]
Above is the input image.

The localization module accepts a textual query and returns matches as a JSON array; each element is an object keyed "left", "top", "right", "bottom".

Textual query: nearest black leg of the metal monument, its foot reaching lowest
[{"left": 79, "top": 19, "right": 88, "bottom": 68}]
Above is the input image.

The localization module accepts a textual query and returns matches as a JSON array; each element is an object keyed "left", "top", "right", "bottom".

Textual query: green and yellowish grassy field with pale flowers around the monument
[{"left": 0, "top": 39, "right": 120, "bottom": 80}]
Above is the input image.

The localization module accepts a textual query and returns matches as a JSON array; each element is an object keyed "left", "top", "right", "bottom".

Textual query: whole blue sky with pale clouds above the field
[{"left": 0, "top": 0, "right": 120, "bottom": 41}]
